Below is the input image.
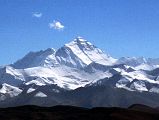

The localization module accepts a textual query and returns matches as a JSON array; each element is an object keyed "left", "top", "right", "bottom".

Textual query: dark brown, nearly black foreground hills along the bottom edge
[{"left": 0, "top": 104, "right": 159, "bottom": 120}]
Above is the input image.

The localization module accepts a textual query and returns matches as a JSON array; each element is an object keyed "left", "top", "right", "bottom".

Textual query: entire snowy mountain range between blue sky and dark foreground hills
[{"left": 0, "top": 37, "right": 159, "bottom": 107}]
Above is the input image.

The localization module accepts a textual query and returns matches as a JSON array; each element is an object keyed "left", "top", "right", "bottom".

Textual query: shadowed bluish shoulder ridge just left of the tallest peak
[{"left": 11, "top": 48, "right": 58, "bottom": 69}]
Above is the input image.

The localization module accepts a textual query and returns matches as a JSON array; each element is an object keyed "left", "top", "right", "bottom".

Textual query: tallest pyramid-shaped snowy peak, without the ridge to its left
[{"left": 55, "top": 37, "right": 116, "bottom": 68}]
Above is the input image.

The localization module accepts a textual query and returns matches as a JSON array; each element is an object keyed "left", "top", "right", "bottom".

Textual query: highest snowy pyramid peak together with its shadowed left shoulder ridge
[{"left": 13, "top": 37, "right": 115, "bottom": 69}]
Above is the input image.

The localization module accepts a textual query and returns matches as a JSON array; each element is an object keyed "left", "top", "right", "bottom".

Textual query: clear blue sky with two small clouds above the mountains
[{"left": 0, "top": 0, "right": 159, "bottom": 65}]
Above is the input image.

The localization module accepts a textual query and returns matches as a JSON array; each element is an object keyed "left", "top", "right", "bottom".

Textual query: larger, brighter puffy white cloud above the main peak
[{"left": 49, "top": 20, "right": 65, "bottom": 30}]
